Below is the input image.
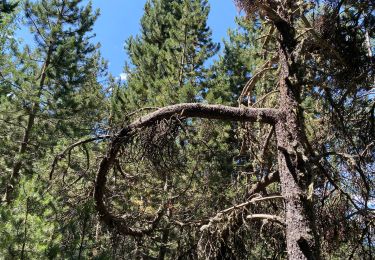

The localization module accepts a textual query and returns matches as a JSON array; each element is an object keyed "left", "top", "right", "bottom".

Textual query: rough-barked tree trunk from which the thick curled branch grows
[{"left": 276, "top": 17, "right": 320, "bottom": 260}]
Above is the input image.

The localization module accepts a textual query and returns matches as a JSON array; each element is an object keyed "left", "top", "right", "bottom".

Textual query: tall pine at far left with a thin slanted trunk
[{"left": 5, "top": 0, "right": 106, "bottom": 202}]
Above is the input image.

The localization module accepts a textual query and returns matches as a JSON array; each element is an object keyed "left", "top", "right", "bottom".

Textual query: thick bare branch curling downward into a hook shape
[{"left": 94, "top": 103, "right": 279, "bottom": 236}]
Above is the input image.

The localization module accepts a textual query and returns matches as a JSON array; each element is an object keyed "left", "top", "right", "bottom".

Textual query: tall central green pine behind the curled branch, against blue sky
[{"left": 104, "top": 0, "right": 219, "bottom": 259}]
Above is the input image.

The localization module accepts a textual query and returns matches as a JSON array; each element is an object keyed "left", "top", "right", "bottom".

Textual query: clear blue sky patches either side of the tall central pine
[{"left": 89, "top": 0, "right": 238, "bottom": 76}]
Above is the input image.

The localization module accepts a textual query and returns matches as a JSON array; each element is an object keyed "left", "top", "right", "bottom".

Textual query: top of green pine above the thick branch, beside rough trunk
[{"left": 204, "top": 17, "right": 274, "bottom": 106}]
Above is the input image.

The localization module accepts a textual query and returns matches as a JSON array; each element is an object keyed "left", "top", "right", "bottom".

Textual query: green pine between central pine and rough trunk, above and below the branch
[{"left": 200, "top": 17, "right": 284, "bottom": 259}]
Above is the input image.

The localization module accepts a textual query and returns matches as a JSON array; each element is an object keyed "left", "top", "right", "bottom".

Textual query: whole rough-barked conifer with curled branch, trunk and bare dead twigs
[{"left": 94, "top": 0, "right": 374, "bottom": 259}]
